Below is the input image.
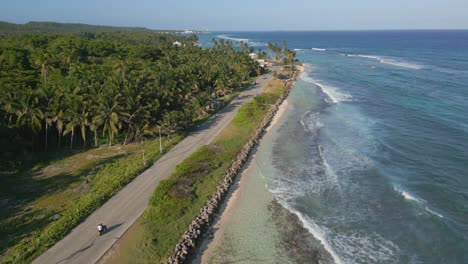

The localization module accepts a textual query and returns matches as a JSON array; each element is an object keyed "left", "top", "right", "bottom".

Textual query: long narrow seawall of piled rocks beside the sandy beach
[{"left": 167, "top": 71, "right": 298, "bottom": 264}]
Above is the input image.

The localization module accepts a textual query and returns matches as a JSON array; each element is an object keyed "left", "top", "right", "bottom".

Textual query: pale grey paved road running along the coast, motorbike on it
[{"left": 33, "top": 75, "right": 272, "bottom": 264}]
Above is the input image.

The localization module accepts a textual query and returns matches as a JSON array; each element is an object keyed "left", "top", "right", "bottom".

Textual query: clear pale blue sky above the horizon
[{"left": 0, "top": 0, "right": 468, "bottom": 31}]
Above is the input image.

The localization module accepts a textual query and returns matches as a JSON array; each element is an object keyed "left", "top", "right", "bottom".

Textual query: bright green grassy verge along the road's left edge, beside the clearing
[{"left": 1, "top": 136, "right": 182, "bottom": 263}]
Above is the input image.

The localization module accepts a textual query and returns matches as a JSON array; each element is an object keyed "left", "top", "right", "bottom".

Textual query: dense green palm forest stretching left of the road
[{"left": 0, "top": 32, "right": 261, "bottom": 169}]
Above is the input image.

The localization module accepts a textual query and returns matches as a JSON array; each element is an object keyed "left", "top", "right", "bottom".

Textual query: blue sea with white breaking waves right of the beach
[{"left": 199, "top": 30, "right": 468, "bottom": 263}]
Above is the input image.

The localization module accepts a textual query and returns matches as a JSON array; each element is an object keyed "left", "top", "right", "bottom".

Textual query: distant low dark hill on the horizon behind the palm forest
[{"left": 0, "top": 21, "right": 180, "bottom": 34}]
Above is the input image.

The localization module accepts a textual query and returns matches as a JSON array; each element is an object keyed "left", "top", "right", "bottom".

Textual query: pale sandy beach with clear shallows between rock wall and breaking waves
[{"left": 192, "top": 64, "right": 332, "bottom": 263}]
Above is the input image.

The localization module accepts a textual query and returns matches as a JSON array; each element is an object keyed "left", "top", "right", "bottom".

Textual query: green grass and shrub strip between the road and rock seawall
[{"left": 127, "top": 80, "right": 284, "bottom": 263}]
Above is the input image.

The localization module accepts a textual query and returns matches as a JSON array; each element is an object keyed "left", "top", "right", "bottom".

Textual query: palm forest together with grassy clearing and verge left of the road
[{"left": 0, "top": 29, "right": 259, "bottom": 263}]
